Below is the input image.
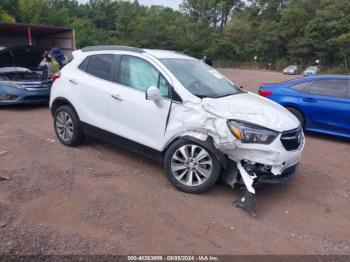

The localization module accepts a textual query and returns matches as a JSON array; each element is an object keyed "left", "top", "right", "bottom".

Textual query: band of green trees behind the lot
[{"left": 0, "top": 0, "right": 350, "bottom": 71}]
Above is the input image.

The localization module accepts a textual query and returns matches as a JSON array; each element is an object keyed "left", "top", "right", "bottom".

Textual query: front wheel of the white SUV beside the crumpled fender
[{"left": 164, "top": 140, "right": 221, "bottom": 194}]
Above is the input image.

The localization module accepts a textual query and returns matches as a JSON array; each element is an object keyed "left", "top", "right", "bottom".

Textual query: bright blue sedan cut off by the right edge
[{"left": 259, "top": 75, "right": 350, "bottom": 138}]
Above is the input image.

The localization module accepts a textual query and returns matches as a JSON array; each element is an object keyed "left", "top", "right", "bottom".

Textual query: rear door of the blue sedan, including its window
[{"left": 301, "top": 78, "right": 350, "bottom": 133}]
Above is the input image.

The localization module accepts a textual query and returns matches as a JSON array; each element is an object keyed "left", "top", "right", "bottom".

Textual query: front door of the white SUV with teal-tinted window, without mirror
[{"left": 109, "top": 55, "right": 171, "bottom": 150}]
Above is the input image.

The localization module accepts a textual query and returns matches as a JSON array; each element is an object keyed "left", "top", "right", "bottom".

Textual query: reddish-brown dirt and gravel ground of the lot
[{"left": 0, "top": 70, "right": 350, "bottom": 254}]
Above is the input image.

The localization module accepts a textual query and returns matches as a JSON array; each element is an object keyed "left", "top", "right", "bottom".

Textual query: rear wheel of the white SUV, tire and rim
[{"left": 54, "top": 105, "right": 84, "bottom": 147}]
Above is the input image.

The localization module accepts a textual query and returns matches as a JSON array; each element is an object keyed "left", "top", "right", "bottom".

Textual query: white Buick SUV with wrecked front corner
[{"left": 50, "top": 46, "right": 304, "bottom": 201}]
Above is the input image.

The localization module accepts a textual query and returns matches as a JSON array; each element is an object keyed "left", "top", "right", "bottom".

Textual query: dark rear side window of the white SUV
[{"left": 79, "top": 54, "right": 115, "bottom": 80}]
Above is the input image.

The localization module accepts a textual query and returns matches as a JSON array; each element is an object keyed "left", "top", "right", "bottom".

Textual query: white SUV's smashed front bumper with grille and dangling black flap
[{"left": 220, "top": 128, "right": 305, "bottom": 216}]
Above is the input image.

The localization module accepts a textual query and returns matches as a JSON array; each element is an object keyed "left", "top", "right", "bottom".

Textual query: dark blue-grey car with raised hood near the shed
[{"left": 0, "top": 46, "right": 52, "bottom": 105}]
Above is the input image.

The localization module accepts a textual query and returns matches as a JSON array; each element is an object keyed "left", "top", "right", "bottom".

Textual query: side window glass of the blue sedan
[{"left": 309, "top": 79, "right": 348, "bottom": 98}]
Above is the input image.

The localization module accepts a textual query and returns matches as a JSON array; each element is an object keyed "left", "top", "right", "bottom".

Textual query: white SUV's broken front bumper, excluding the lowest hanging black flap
[{"left": 220, "top": 129, "right": 305, "bottom": 186}]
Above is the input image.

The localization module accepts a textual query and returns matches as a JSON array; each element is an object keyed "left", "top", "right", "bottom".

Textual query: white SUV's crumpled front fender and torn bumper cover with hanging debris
[{"left": 167, "top": 101, "right": 299, "bottom": 215}]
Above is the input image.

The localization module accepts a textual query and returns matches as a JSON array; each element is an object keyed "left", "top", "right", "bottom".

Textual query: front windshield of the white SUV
[{"left": 160, "top": 58, "right": 244, "bottom": 98}]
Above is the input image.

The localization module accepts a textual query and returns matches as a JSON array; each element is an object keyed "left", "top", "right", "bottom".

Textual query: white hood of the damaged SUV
[{"left": 202, "top": 93, "right": 300, "bottom": 132}]
